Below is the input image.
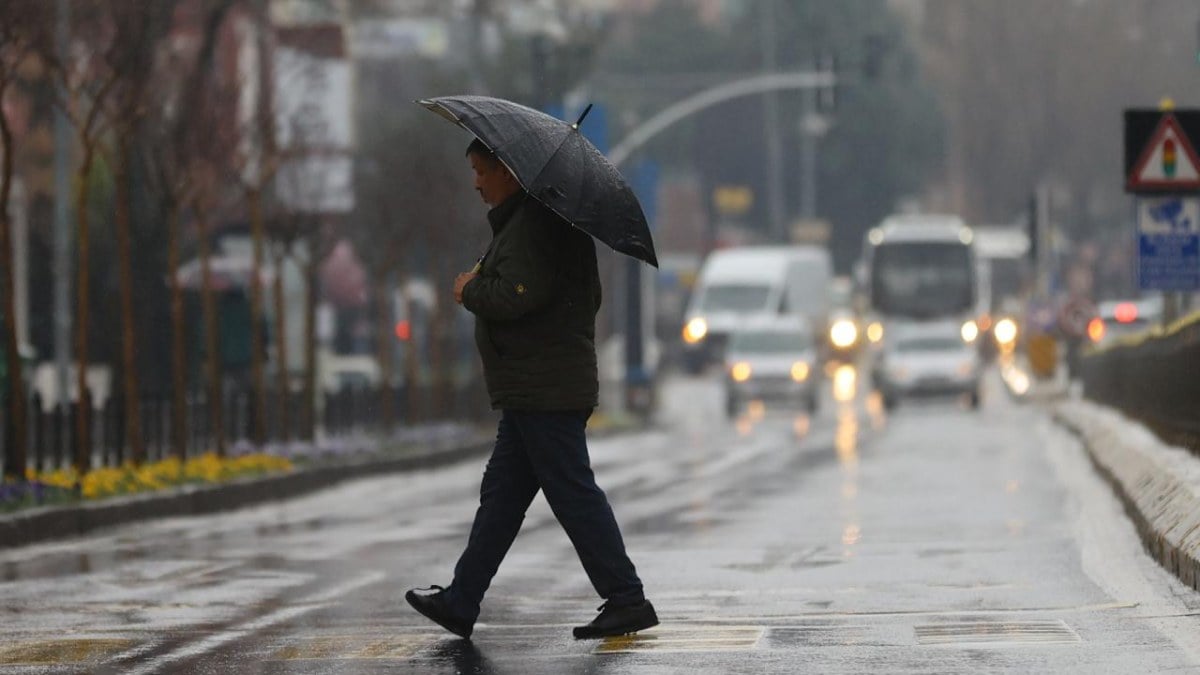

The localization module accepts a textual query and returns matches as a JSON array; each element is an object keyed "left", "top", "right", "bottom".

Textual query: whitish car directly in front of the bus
[{"left": 871, "top": 322, "right": 982, "bottom": 410}]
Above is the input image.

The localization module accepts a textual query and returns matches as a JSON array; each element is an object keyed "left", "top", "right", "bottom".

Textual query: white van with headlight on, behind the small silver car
[{"left": 683, "top": 246, "right": 833, "bottom": 372}]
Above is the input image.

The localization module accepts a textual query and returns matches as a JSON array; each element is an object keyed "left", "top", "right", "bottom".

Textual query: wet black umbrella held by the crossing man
[{"left": 418, "top": 96, "right": 659, "bottom": 267}]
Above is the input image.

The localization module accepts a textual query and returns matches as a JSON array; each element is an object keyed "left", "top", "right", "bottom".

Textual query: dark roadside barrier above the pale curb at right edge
[{"left": 1080, "top": 312, "right": 1200, "bottom": 454}]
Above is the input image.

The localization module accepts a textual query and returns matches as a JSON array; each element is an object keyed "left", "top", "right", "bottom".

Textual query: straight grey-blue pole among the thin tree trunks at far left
[{"left": 54, "top": 0, "right": 71, "bottom": 404}]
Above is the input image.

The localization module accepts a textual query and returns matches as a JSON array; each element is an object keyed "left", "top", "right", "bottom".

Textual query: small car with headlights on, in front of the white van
[{"left": 725, "top": 318, "right": 821, "bottom": 417}]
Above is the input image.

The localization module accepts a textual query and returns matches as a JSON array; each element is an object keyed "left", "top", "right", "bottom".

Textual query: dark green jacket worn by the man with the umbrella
[{"left": 462, "top": 191, "right": 600, "bottom": 411}]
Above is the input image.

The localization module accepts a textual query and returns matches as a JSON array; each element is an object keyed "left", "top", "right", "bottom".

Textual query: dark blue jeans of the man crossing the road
[{"left": 446, "top": 410, "right": 644, "bottom": 621}]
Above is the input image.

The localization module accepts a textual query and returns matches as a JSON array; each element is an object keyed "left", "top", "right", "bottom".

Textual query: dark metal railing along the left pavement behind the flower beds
[{"left": 0, "top": 380, "right": 488, "bottom": 471}]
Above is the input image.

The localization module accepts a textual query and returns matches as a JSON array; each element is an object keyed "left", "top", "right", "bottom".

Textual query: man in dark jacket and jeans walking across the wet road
[{"left": 404, "top": 141, "right": 659, "bottom": 639}]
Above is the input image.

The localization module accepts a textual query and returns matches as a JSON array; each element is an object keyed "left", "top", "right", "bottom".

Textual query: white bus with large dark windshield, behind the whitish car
[{"left": 859, "top": 214, "right": 980, "bottom": 345}]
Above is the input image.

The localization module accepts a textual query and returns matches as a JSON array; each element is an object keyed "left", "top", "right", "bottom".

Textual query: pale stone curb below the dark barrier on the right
[{"left": 1052, "top": 402, "right": 1200, "bottom": 591}]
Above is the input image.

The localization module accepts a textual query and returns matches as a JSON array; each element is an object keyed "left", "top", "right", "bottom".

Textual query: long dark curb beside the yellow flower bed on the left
[{"left": 0, "top": 438, "right": 492, "bottom": 549}]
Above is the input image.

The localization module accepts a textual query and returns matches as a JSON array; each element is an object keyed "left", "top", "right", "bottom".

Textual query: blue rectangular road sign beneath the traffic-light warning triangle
[{"left": 1138, "top": 196, "right": 1200, "bottom": 291}]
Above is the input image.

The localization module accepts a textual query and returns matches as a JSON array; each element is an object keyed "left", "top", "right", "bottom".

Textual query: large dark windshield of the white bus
[{"left": 871, "top": 241, "right": 974, "bottom": 318}]
